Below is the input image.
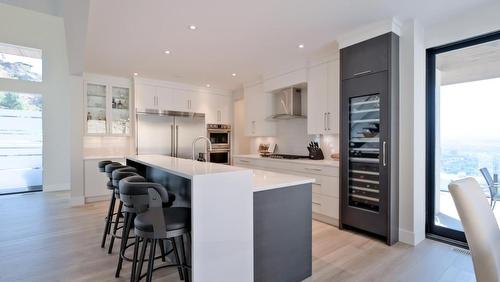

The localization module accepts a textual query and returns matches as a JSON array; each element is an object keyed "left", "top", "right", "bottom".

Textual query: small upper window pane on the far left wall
[{"left": 0, "top": 43, "right": 42, "bottom": 82}]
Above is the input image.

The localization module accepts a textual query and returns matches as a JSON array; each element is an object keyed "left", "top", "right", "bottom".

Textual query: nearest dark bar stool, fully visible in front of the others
[{"left": 132, "top": 184, "right": 191, "bottom": 282}]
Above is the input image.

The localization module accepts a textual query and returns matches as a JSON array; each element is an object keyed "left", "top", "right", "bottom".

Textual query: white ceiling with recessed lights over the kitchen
[{"left": 80, "top": 0, "right": 494, "bottom": 89}]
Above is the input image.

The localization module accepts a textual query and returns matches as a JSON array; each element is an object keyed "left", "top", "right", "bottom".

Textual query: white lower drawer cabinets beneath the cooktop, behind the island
[{"left": 233, "top": 157, "right": 340, "bottom": 226}]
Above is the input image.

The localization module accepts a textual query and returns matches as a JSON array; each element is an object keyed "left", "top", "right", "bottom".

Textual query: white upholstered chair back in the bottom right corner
[{"left": 448, "top": 177, "right": 500, "bottom": 282}]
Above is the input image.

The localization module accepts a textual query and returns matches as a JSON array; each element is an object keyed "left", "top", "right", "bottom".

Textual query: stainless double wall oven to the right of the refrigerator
[{"left": 207, "top": 124, "right": 231, "bottom": 165}]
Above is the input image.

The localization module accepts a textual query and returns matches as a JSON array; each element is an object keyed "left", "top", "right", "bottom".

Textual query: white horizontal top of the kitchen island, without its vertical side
[{"left": 126, "top": 155, "right": 315, "bottom": 192}]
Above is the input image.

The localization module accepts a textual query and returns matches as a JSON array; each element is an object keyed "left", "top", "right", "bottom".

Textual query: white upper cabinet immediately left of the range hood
[{"left": 244, "top": 83, "right": 276, "bottom": 136}]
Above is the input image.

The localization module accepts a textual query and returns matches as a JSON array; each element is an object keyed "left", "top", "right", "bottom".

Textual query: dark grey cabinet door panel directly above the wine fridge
[{"left": 340, "top": 34, "right": 390, "bottom": 79}]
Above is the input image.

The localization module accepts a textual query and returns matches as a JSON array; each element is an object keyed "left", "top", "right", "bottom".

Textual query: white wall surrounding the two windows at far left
[{"left": 0, "top": 4, "right": 79, "bottom": 191}]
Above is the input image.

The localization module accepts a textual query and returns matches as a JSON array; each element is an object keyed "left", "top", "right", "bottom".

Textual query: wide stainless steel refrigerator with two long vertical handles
[{"left": 136, "top": 112, "right": 207, "bottom": 159}]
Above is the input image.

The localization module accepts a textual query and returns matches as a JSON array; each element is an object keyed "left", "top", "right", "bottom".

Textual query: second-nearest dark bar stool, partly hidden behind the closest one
[{"left": 113, "top": 173, "right": 175, "bottom": 277}]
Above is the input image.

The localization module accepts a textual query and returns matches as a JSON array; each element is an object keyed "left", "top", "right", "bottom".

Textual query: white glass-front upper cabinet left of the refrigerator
[{"left": 85, "top": 81, "right": 131, "bottom": 135}]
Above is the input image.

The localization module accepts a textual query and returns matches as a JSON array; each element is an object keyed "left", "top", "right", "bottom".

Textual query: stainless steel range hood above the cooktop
[{"left": 269, "top": 87, "right": 307, "bottom": 120}]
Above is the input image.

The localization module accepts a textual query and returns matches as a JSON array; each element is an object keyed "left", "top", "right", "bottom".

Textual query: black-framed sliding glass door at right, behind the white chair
[{"left": 427, "top": 31, "right": 500, "bottom": 244}]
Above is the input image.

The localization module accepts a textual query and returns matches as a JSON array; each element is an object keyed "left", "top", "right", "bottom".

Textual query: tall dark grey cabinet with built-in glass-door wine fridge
[{"left": 340, "top": 32, "right": 399, "bottom": 245}]
